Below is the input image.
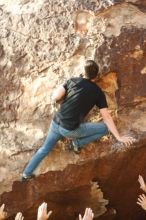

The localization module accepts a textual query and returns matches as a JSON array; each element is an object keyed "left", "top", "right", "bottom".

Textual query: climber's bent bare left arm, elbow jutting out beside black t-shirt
[{"left": 51, "top": 85, "right": 66, "bottom": 102}]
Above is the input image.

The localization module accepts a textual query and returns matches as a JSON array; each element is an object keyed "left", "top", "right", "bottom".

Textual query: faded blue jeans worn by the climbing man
[{"left": 23, "top": 121, "right": 108, "bottom": 176}]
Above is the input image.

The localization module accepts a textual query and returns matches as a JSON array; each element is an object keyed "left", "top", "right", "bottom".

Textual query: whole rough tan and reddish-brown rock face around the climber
[{"left": 0, "top": 0, "right": 146, "bottom": 220}]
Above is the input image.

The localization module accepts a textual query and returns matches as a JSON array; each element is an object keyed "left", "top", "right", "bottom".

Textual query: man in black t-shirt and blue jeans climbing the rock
[{"left": 22, "top": 60, "right": 133, "bottom": 180}]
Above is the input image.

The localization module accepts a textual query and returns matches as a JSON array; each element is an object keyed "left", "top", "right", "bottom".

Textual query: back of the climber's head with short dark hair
[{"left": 84, "top": 60, "right": 99, "bottom": 79}]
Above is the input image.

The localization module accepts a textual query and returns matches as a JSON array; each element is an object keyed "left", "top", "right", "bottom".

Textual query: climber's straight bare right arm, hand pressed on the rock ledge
[{"left": 100, "top": 108, "right": 135, "bottom": 146}]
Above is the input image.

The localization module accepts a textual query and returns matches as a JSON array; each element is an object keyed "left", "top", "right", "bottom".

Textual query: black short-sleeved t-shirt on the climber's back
[{"left": 53, "top": 77, "right": 108, "bottom": 130}]
